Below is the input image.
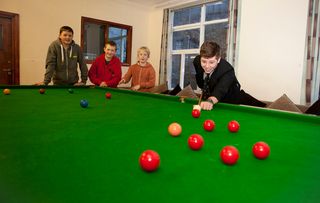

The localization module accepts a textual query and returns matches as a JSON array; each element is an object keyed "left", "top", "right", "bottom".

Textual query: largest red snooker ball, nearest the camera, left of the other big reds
[{"left": 139, "top": 150, "right": 160, "bottom": 172}]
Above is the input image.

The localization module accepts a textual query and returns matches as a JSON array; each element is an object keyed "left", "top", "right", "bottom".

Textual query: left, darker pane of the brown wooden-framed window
[{"left": 83, "top": 23, "right": 106, "bottom": 60}]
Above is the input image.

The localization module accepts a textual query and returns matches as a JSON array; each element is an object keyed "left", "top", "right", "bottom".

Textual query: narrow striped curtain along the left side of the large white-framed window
[{"left": 159, "top": 9, "right": 169, "bottom": 85}]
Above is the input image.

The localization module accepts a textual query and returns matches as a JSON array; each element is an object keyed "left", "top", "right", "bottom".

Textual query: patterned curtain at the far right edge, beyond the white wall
[{"left": 305, "top": 0, "right": 320, "bottom": 104}]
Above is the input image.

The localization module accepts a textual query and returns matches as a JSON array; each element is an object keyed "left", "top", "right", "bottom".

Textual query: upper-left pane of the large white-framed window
[{"left": 173, "top": 6, "right": 201, "bottom": 26}]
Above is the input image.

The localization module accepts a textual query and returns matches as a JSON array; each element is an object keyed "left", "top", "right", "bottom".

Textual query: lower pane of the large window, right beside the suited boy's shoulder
[{"left": 183, "top": 54, "right": 197, "bottom": 90}]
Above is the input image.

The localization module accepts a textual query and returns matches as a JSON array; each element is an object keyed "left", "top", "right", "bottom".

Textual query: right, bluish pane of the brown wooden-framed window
[{"left": 108, "top": 27, "right": 127, "bottom": 63}]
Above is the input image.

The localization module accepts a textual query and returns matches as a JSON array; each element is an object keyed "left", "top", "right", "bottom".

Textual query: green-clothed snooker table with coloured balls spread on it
[{"left": 0, "top": 86, "right": 320, "bottom": 203}]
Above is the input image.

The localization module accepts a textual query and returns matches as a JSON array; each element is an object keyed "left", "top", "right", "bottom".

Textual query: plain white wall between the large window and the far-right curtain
[{"left": 237, "top": 0, "right": 308, "bottom": 103}]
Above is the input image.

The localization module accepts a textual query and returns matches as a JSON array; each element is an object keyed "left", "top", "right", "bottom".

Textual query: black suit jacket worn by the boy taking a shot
[{"left": 193, "top": 55, "right": 240, "bottom": 104}]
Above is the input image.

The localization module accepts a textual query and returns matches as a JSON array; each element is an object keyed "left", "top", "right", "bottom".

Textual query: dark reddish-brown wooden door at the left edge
[{"left": 0, "top": 11, "right": 19, "bottom": 85}]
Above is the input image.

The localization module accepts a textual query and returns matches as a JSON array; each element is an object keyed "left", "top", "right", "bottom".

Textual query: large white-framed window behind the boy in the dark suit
[{"left": 167, "top": 0, "right": 229, "bottom": 89}]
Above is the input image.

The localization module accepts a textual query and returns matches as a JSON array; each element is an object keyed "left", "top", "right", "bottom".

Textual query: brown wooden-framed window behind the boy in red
[{"left": 81, "top": 17, "right": 132, "bottom": 66}]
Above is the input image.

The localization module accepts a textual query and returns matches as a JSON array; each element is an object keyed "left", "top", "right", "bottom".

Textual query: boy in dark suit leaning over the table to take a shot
[{"left": 193, "top": 41, "right": 266, "bottom": 110}]
